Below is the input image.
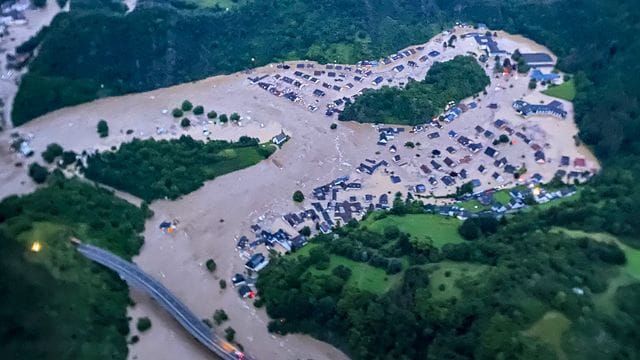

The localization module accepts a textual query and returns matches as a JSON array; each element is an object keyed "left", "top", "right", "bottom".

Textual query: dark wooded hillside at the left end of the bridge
[{"left": 0, "top": 176, "right": 146, "bottom": 359}]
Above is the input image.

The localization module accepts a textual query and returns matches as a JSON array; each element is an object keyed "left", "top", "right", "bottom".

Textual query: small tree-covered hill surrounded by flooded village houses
[{"left": 340, "top": 56, "right": 490, "bottom": 125}]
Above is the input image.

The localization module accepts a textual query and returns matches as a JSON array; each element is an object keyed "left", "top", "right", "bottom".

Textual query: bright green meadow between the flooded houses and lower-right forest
[{"left": 365, "top": 214, "right": 464, "bottom": 247}]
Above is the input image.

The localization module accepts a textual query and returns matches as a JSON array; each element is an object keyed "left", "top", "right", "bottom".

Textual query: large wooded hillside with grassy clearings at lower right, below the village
[{"left": 257, "top": 201, "right": 640, "bottom": 359}]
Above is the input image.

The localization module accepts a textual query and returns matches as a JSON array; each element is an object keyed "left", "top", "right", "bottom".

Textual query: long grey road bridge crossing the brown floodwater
[{"left": 73, "top": 240, "right": 255, "bottom": 360}]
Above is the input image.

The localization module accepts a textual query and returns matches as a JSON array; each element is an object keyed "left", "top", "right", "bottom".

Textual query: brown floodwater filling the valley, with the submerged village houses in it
[{"left": 0, "top": 21, "right": 599, "bottom": 359}]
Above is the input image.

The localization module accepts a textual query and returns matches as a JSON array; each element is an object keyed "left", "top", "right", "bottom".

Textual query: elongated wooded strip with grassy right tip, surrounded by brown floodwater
[{"left": 84, "top": 135, "right": 275, "bottom": 201}]
